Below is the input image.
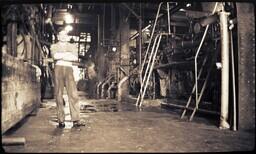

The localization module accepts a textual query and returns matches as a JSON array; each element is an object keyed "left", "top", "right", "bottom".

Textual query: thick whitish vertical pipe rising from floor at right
[{"left": 219, "top": 9, "right": 230, "bottom": 129}]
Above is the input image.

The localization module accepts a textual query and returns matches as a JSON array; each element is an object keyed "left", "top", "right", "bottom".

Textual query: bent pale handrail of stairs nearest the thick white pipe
[{"left": 195, "top": 2, "right": 218, "bottom": 109}]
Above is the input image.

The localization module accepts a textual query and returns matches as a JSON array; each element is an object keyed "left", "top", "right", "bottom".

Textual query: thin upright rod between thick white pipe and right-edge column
[{"left": 230, "top": 28, "right": 237, "bottom": 131}]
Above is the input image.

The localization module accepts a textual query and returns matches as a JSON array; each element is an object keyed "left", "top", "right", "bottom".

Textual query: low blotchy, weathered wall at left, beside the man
[{"left": 1, "top": 54, "right": 41, "bottom": 134}]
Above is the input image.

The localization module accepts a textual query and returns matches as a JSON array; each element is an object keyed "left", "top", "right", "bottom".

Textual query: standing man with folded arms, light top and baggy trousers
[{"left": 51, "top": 29, "right": 85, "bottom": 128}]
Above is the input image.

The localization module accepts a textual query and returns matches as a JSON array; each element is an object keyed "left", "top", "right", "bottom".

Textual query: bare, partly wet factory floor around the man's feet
[{"left": 3, "top": 94, "right": 255, "bottom": 153}]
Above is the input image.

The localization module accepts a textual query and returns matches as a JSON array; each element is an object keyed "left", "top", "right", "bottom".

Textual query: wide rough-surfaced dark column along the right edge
[{"left": 237, "top": 3, "right": 255, "bottom": 130}]
